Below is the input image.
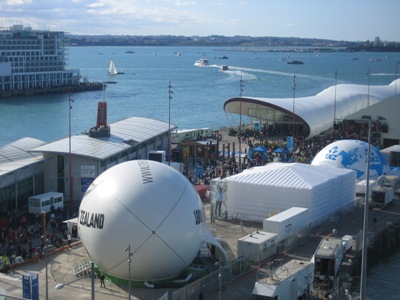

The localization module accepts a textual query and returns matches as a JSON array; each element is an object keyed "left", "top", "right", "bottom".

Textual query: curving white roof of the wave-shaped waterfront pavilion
[{"left": 224, "top": 79, "right": 400, "bottom": 137}]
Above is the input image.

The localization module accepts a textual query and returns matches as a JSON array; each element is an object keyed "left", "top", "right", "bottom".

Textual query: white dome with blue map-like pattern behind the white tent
[{"left": 311, "top": 140, "right": 390, "bottom": 180}]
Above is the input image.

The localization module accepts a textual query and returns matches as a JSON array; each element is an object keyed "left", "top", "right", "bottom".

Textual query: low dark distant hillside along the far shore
[{"left": 66, "top": 34, "right": 400, "bottom": 52}]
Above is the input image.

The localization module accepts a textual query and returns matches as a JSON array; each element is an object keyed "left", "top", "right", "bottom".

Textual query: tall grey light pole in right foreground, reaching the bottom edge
[{"left": 360, "top": 120, "right": 371, "bottom": 300}]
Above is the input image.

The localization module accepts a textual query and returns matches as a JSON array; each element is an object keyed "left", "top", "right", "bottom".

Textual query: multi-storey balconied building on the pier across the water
[{"left": 0, "top": 25, "right": 100, "bottom": 97}]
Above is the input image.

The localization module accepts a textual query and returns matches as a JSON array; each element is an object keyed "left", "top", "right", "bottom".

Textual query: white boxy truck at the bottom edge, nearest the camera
[{"left": 251, "top": 259, "right": 314, "bottom": 300}]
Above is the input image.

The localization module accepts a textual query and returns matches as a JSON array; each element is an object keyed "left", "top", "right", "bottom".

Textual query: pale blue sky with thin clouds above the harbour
[{"left": 0, "top": 0, "right": 400, "bottom": 42}]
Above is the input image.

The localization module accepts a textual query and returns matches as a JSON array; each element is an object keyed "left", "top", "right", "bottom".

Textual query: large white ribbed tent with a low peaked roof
[{"left": 223, "top": 163, "right": 356, "bottom": 226}]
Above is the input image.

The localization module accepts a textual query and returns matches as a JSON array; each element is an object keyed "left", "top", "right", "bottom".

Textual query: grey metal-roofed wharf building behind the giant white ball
[{"left": 0, "top": 113, "right": 175, "bottom": 221}]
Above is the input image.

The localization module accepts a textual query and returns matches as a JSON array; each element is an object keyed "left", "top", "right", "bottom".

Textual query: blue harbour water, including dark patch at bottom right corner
[{"left": 0, "top": 47, "right": 400, "bottom": 299}]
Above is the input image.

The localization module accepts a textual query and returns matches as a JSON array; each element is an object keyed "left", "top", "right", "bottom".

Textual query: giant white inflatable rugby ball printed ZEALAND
[{"left": 78, "top": 160, "right": 206, "bottom": 281}]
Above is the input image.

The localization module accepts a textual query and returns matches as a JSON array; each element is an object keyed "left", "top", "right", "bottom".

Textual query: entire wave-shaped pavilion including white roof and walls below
[{"left": 224, "top": 79, "right": 400, "bottom": 148}]
